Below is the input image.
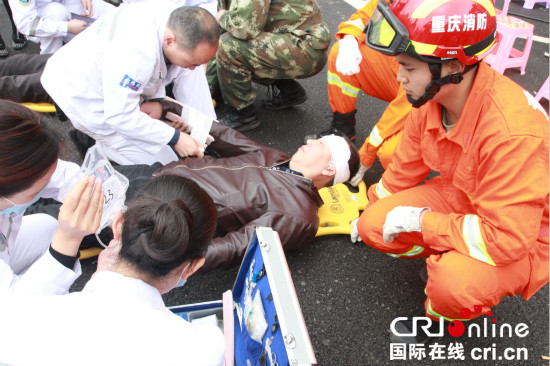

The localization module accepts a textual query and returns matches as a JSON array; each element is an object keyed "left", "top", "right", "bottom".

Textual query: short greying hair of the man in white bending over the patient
[{"left": 167, "top": 6, "right": 220, "bottom": 51}]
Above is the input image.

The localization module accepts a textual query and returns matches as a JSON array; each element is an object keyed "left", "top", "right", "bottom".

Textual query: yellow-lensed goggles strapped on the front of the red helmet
[{"left": 365, "top": 0, "right": 411, "bottom": 56}]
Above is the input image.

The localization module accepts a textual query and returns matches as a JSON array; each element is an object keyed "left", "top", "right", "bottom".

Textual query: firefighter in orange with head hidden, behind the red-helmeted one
[{"left": 308, "top": 0, "right": 411, "bottom": 185}]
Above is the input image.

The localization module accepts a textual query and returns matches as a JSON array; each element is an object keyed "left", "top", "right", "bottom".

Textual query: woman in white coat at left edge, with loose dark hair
[{"left": 0, "top": 100, "right": 103, "bottom": 294}]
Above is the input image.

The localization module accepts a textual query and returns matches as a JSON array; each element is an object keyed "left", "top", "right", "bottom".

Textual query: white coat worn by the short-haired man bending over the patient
[{"left": 41, "top": 1, "right": 210, "bottom": 165}]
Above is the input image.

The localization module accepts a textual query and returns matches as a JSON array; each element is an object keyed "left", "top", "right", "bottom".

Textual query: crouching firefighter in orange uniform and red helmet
[{"left": 352, "top": 0, "right": 549, "bottom": 343}]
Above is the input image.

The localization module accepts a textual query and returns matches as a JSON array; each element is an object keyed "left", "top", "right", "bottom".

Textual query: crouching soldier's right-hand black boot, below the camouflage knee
[{"left": 263, "top": 79, "right": 307, "bottom": 110}]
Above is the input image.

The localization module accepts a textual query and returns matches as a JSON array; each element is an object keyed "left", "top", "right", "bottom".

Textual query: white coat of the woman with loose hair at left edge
[{"left": 0, "top": 160, "right": 81, "bottom": 296}]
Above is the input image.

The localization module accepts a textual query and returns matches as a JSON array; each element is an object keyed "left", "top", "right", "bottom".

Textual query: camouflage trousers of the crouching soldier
[{"left": 208, "top": 33, "right": 327, "bottom": 109}]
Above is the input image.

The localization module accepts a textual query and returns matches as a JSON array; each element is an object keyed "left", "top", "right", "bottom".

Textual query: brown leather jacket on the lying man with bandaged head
[{"left": 154, "top": 123, "right": 323, "bottom": 271}]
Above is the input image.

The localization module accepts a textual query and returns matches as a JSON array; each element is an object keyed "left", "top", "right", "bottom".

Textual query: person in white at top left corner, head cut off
[{"left": 9, "top": 0, "right": 115, "bottom": 54}]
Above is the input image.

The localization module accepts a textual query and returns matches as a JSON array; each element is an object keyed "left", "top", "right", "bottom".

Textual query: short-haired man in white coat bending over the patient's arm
[{"left": 41, "top": 1, "right": 219, "bottom": 165}]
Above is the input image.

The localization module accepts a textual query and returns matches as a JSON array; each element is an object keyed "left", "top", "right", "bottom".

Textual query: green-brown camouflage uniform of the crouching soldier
[{"left": 207, "top": 0, "right": 330, "bottom": 109}]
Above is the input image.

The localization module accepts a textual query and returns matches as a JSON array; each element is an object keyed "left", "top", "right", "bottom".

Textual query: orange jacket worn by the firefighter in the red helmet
[{"left": 368, "top": 62, "right": 549, "bottom": 298}]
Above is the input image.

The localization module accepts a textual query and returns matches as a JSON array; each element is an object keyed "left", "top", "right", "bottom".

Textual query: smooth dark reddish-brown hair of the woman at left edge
[{"left": 0, "top": 99, "right": 60, "bottom": 197}]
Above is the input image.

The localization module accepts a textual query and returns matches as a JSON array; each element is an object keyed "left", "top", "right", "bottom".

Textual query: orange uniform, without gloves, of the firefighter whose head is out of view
[{"left": 328, "top": 0, "right": 412, "bottom": 166}]
